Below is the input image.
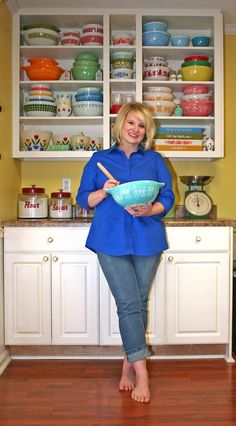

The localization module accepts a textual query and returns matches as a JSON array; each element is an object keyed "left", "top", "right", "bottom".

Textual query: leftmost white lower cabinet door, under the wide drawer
[{"left": 4, "top": 253, "right": 51, "bottom": 345}]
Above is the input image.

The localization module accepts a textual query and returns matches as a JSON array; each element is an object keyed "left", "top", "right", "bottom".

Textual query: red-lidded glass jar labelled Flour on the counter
[{"left": 18, "top": 185, "right": 48, "bottom": 219}]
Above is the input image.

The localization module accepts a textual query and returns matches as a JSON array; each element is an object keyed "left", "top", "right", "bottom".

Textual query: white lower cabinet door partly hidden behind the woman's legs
[{"left": 100, "top": 260, "right": 165, "bottom": 345}]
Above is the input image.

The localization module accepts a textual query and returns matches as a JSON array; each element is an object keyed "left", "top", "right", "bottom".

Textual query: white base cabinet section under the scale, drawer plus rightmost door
[{"left": 165, "top": 227, "right": 232, "bottom": 344}]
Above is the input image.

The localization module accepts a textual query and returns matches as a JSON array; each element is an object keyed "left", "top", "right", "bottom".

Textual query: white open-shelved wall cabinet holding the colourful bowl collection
[{"left": 13, "top": 8, "right": 224, "bottom": 160}]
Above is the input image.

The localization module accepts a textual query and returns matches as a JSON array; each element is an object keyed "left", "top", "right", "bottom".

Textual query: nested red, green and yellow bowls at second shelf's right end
[{"left": 181, "top": 55, "right": 213, "bottom": 81}]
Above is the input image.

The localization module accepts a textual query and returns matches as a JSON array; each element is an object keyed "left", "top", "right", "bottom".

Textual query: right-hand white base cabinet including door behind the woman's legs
[{"left": 100, "top": 227, "right": 232, "bottom": 352}]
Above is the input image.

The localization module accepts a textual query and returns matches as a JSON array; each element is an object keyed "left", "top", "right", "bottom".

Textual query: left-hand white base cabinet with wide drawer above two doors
[{"left": 4, "top": 228, "right": 99, "bottom": 344}]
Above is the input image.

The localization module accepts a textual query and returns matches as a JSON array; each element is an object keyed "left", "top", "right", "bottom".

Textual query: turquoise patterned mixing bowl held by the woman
[{"left": 106, "top": 180, "right": 165, "bottom": 207}]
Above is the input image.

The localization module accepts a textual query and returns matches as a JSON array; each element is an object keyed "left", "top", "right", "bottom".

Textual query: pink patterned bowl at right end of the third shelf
[{"left": 181, "top": 99, "right": 214, "bottom": 117}]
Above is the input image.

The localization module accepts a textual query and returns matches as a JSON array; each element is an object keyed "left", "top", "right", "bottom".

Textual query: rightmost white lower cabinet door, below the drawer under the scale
[{"left": 166, "top": 251, "right": 230, "bottom": 344}]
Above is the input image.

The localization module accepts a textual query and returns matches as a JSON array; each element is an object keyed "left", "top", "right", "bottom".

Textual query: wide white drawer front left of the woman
[{"left": 4, "top": 227, "right": 89, "bottom": 252}]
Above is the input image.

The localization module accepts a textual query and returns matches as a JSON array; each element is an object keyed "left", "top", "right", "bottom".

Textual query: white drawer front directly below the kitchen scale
[{"left": 167, "top": 226, "right": 230, "bottom": 251}]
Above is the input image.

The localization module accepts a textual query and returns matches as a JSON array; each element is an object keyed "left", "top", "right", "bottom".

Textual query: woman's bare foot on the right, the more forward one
[{"left": 131, "top": 359, "right": 150, "bottom": 403}]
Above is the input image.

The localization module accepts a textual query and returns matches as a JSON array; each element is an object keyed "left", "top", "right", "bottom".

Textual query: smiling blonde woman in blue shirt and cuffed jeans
[{"left": 77, "top": 103, "right": 174, "bottom": 402}]
